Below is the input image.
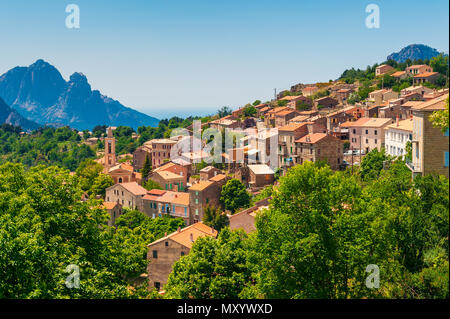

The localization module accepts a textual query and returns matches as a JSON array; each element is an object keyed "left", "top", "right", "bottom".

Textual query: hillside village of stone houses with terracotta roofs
[{"left": 85, "top": 57, "right": 449, "bottom": 293}]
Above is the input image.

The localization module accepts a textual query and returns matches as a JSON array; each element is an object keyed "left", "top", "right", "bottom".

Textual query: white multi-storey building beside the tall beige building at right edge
[{"left": 384, "top": 118, "right": 413, "bottom": 158}]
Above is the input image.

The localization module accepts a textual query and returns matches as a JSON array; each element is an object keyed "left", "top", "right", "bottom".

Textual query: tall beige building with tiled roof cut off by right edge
[{"left": 409, "top": 94, "right": 449, "bottom": 178}]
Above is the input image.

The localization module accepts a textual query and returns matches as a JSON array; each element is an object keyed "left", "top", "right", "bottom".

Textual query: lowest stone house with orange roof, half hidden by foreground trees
[{"left": 147, "top": 222, "right": 217, "bottom": 290}]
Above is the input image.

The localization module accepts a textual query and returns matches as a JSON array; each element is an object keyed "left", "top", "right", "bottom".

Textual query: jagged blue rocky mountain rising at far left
[{"left": 0, "top": 60, "right": 159, "bottom": 130}]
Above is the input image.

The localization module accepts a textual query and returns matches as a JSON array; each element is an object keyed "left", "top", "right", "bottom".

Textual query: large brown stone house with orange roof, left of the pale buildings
[{"left": 295, "top": 133, "right": 344, "bottom": 170}]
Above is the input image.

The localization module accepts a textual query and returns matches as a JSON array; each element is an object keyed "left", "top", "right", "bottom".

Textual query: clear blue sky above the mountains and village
[{"left": 0, "top": 0, "right": 449, "bottom": 118}]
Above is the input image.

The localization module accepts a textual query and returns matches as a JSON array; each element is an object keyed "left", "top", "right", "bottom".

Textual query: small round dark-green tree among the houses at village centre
[{"left": 220, "top": 179, "right": 250, "bottom": 214}]
